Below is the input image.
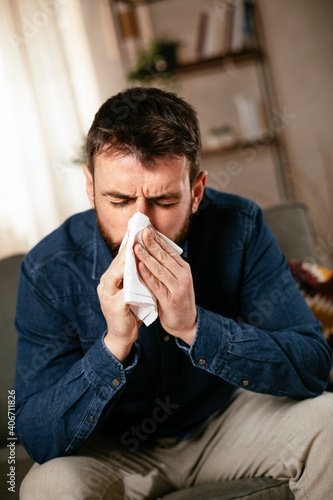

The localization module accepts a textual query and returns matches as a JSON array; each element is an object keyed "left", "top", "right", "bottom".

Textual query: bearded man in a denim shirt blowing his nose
[{"left": 16, "top": 89, "right": 333, "bottom": 500}]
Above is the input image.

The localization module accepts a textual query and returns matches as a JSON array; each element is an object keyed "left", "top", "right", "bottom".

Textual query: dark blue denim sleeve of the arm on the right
[{"left": 177, "top": 205, "right": 332, "bottom": 399}]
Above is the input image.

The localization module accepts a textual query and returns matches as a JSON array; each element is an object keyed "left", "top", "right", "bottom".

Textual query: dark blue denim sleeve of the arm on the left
[{"left": 15, "top": 261, "right": 138, "bottom": 463}]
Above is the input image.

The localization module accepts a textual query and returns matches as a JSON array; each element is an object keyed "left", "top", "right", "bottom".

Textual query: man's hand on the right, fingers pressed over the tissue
[{"left": 134, "top": 227, "right": 197, "bottom": 345}]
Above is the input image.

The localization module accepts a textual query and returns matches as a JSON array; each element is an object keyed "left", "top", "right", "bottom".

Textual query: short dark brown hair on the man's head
[{"left": 86, "top": 87, "right": 201, "bottom": 185}]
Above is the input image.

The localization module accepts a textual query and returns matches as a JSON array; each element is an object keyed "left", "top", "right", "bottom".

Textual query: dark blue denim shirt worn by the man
[{"left": 15, "top": 189, "right": 332, "bottom": 463}]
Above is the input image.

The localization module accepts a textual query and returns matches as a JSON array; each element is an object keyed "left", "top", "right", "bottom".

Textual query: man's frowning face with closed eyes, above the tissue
[{"left": 84, "top": 155, "right": 206, "bottom": 255}]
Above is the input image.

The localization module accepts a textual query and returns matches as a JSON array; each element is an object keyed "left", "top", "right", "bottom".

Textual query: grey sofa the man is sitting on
[{"left": 0, "top": 202, "right": 330, "bottom": 500}]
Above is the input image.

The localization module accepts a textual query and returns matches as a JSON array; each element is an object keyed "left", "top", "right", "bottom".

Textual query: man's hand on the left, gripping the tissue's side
[{"left": 97, "top": 245, "right": 142, "bottom": 363}]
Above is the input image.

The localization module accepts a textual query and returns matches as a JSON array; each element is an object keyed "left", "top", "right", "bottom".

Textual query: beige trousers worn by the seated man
[{"left": 20, "top": 390, "right": 333, "bottom": 500}]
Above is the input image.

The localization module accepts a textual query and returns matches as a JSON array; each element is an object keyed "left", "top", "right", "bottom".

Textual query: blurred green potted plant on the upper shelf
[{"left": 129, "top": 38, "right": 180, "bottom": 81}]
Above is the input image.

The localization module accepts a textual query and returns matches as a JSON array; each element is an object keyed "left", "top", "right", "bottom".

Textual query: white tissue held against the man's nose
[{"left": 119, "top": 212, "right": 183, "bottom": 326}]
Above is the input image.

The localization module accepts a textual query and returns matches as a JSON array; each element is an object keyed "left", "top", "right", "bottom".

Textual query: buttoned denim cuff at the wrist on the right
[{"left": 176, "top": 306, "right": 230, "bottom": 375}]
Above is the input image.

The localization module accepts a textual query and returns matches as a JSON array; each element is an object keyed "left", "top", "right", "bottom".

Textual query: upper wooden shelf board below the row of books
[{"left": 174, "top": 50, "right": 262, "bottom": 75}]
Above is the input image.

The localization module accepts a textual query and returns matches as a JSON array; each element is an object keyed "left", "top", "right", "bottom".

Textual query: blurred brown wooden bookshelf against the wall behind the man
[{"left": 110, "top": 0, "right": 294, "bottom": 201}]
